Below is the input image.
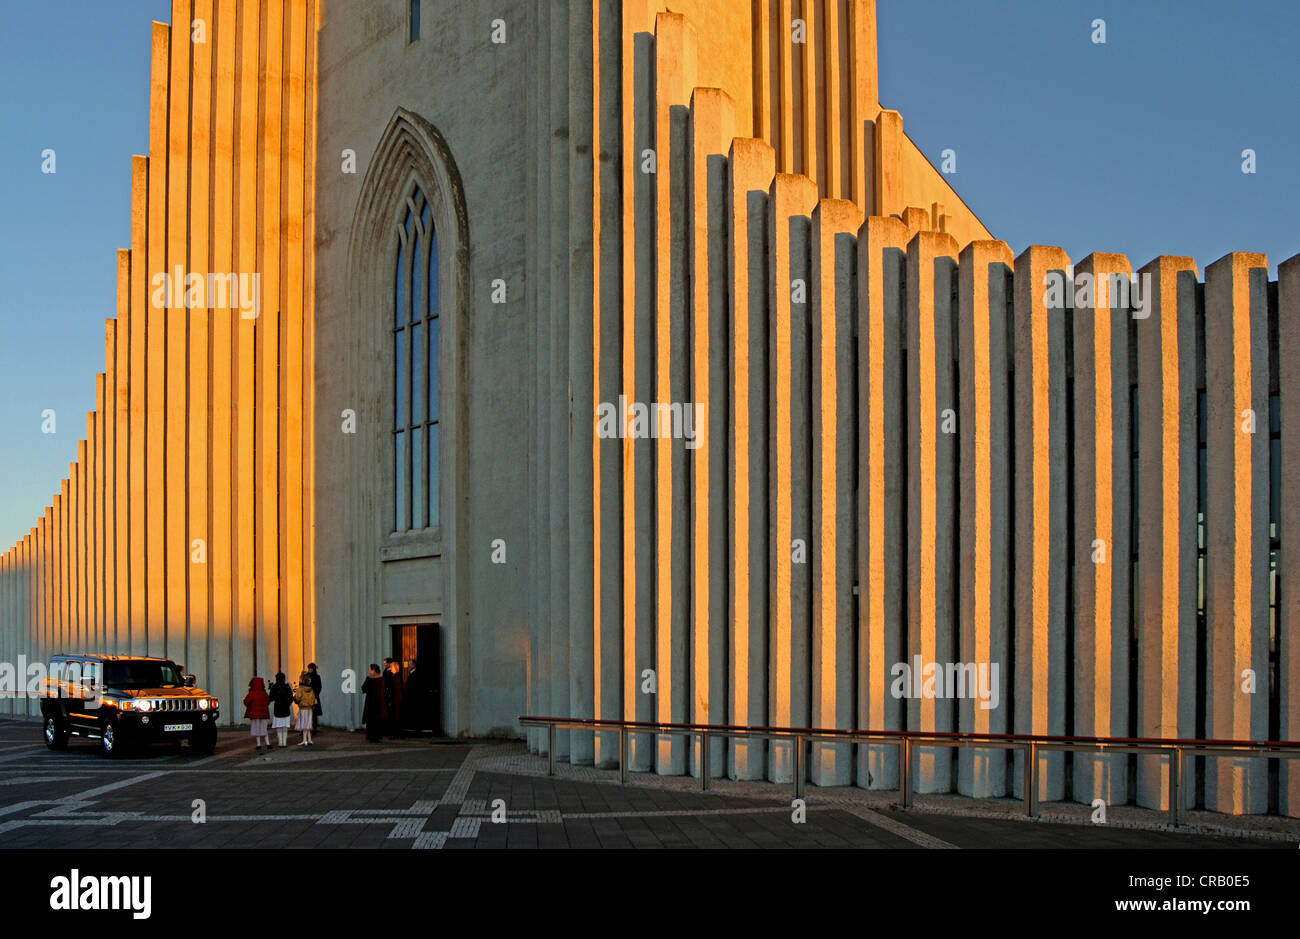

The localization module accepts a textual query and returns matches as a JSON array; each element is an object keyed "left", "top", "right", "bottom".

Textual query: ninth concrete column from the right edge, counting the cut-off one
[{"left": 809, "top": 199, "right": 862, "bottom": 786}]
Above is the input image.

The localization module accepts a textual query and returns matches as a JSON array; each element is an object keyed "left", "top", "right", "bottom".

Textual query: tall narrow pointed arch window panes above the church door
[{"left": 393, "top": 186, "right": 441, "bottom": 532}]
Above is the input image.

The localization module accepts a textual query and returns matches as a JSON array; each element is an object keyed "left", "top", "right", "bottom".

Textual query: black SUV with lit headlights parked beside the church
[{"left": 40, "top": 653, "right": 221, "bottom": 757}]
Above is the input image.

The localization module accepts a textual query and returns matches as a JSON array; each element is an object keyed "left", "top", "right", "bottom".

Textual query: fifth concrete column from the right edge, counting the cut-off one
[{"left": 1011, "top": 245, "right": 1073, "bottom": 801}]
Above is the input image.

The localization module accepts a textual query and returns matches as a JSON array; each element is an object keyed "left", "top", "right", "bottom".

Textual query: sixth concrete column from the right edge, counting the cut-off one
[{"left": 957, "top": 241, "right": 1013, "bottom": 797}]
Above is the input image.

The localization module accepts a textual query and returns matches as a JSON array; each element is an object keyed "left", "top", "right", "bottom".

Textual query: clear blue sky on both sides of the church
[{"left": 0, "top": 0, "right": 1300, "bottom": 549}]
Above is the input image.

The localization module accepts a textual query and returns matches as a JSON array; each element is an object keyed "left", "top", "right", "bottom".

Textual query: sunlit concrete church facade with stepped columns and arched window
[{"left": 0, "top": 0, "right": 1300, "bottom": 815}]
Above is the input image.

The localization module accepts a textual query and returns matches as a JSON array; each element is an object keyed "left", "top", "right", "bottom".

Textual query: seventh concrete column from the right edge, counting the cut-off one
[{"left": 905, "top": 231, "right": 959, "bottom": 792}]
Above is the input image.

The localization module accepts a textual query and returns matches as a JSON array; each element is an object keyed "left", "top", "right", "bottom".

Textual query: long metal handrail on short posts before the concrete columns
[{"left": 519, "top": 714, "right": 1300, "bottom": 827}]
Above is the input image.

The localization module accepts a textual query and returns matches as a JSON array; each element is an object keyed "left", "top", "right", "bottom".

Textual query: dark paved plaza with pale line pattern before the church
[{"left": 0, "top": 719, "right": 1300, "bottom": 851}]
